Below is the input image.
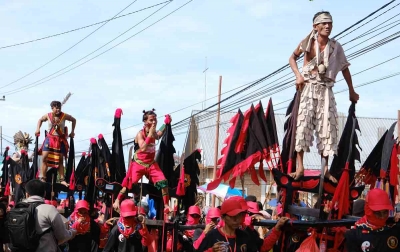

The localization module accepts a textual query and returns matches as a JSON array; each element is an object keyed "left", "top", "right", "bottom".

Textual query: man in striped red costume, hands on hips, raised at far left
[{"left": 36, "top": 101, "right": 76, "bottom": 186}]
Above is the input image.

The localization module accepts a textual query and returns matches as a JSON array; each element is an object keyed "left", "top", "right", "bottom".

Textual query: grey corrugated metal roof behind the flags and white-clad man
[{"left": 186, "top": 111, "right": 397, "bottom": 169}]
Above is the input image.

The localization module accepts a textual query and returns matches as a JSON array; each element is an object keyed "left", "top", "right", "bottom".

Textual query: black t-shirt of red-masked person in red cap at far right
[{"left": 345, "top": 224, "right": 400, "bottom": 252}]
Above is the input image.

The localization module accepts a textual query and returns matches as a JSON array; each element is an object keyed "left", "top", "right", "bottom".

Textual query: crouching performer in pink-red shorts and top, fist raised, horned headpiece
[{"left": 114, "top": 109, "right": 171, "bottom": 213}]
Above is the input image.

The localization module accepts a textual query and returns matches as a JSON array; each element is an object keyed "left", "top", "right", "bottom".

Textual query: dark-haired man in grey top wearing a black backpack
[{"left": 7, "top": 179, "right": 76, "bottom": 252}]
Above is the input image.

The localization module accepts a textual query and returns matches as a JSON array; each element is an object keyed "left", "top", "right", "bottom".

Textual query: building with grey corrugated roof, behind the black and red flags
[{"left": 185, "top": 108, "right": 397, "bottom": 205}]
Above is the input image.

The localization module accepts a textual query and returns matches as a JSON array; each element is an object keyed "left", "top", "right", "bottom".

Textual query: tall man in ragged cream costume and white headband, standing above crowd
[{"left": 289, "top": 11, "right": 359, "bottom": 183}]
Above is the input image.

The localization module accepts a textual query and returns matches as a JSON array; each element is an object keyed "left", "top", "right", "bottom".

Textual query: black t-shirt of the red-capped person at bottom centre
[{"left": 196, "top": 228, "right": 258, "bottom": 252}]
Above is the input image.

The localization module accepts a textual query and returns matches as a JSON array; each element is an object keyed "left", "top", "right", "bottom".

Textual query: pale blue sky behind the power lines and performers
[{"left": 0, "top": 0, "right": 400, "bottom": 162}]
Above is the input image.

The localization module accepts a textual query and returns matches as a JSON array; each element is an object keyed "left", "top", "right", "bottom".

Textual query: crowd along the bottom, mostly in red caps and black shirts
[{"left": 0, "top": 183, "right": 400, "bottom": 252}]
